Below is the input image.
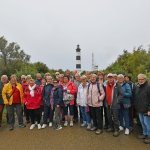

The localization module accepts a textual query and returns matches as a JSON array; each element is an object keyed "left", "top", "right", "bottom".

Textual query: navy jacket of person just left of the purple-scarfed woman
[{"left": 42, "top": 84, "right": 53, "bottom": 106}]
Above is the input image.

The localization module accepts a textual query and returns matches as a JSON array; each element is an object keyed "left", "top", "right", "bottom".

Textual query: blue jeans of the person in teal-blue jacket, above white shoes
[{"left": 119, "top": 105, "right": 130, "bottom": 129}]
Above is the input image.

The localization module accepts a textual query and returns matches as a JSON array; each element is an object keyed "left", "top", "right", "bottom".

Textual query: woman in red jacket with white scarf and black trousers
[{"left": 24, "top": 79, "right": 42, "bottom": 130}]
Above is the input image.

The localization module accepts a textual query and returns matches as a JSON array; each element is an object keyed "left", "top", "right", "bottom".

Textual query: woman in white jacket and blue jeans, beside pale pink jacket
[{"left": 77, "top": 75, "right": 91, "bottom": 130}]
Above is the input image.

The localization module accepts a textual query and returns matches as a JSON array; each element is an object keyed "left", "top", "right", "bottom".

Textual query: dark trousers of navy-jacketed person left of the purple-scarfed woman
[{"left": 43, "top": 106, "right": 54, "bottom": 124}]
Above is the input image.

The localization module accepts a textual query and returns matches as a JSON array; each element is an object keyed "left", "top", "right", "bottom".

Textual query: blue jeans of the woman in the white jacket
[{"left": 80, "top": 106, "right": 91, "bottom": 124}]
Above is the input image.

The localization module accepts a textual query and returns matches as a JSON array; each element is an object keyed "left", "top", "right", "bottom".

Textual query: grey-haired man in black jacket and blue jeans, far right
[{"left": 134, "top": 74, "right": 150, "bottom": 144}]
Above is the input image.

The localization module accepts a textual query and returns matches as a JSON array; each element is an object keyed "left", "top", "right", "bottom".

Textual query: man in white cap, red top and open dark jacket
[{"left": 106, "top": 73, "right": 123, "bottom": 137}]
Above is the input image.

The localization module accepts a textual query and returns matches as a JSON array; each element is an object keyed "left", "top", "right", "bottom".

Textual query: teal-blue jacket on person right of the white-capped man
[{"left": 121, "top": 82, "right": 132, "bottom": 105}]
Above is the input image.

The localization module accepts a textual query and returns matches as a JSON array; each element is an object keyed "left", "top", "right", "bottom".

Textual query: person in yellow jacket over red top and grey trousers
[{"left": 2, "top": 75, "right": 25, "bottom": 131}]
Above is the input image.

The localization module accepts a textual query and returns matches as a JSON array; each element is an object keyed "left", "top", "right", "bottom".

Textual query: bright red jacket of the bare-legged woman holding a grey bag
[{"left": 62, "top": 81, "right": 77, "bottom": 105}]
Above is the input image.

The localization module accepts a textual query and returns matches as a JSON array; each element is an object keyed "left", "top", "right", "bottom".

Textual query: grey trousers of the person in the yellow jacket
[{"left": 6, "top": 104, "right": 23, "bottom": 127}]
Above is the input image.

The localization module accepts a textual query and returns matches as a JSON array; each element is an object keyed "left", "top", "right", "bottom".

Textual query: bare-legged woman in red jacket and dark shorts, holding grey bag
[{"left": 63, "top": 75, "right": 77, "bottom": 127}]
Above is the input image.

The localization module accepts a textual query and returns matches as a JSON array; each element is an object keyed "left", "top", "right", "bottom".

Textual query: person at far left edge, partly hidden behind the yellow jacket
[{"left": 0, "top": 75, "right": 8, "bottom": 127}]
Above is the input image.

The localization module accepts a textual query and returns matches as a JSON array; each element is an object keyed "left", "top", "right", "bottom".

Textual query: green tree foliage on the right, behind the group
[{"left": 105, "top": 46, "right": 150, "bottom": 81}]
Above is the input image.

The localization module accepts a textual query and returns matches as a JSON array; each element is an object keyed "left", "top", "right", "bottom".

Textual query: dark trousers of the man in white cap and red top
[{"left": 107, "top": 106, "right": 119, "bottom": 131}]
